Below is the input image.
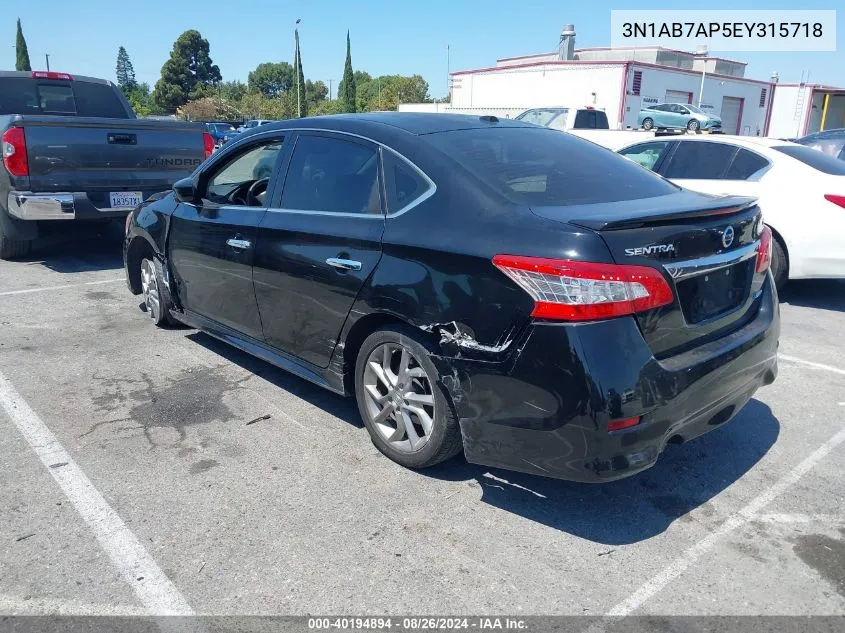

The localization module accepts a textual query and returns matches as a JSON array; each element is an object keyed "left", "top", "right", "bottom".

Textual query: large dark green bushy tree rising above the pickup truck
[{"left": 153, "top": 29, "right": 222, "bottom": 112}]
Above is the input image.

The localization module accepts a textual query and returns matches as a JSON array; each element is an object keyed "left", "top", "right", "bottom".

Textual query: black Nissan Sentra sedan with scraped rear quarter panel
[{"left": 124, "top": 113, "right": 779, "bottom": 482}]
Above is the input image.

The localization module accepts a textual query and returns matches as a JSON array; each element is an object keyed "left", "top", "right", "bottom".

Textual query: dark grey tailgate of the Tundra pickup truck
[{"left": 18, "top": 116, "right": 205, "bottom": 191}]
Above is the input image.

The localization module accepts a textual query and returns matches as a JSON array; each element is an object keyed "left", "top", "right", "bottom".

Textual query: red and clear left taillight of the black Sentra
[{"left": 493, "top": 255, "right": 674, "bottom": 321}]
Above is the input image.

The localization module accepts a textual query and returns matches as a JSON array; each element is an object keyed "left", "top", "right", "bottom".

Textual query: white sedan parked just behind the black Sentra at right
[{"left": 618, "top": 135, "right": 845, "bottom": 288}]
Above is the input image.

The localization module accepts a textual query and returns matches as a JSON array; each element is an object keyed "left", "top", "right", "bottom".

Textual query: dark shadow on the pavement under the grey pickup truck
[{"left": 17, "top": 221, "right": 123, "bottom": 273}]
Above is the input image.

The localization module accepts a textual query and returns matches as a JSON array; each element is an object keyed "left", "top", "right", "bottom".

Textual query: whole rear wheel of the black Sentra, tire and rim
[{"left": 355, "top": 326, "right": 463, "bottom": 468}]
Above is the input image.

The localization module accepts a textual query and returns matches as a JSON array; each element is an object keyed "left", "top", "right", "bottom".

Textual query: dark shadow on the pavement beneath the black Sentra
[{"left": 187, "top": 332, "right": 780, "bottom": 546}]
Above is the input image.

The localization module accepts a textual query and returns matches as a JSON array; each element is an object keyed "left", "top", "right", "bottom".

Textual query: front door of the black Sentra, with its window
[{"left": 167, "top": 134, "right": 285, "bottom": 340}]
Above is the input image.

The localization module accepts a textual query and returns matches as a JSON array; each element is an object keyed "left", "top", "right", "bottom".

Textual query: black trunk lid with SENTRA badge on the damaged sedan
[{"left": 532, "top": 191, "right": 765, "bottom": 358}]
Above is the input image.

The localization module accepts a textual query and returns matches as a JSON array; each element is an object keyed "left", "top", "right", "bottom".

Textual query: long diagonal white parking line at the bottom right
[{"left": 600, "top": 429, "right": 845, "bottom": 616}]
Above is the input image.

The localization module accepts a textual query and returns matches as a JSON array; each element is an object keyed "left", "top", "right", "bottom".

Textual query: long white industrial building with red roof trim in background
[{"left": 401, "top": 25, "right": 845, "bottom": 137}]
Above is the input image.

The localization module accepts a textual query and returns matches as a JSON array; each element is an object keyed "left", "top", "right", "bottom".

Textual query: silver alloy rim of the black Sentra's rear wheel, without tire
[{"left": 363, "top": 343, "right": 436, "bottom": 453}]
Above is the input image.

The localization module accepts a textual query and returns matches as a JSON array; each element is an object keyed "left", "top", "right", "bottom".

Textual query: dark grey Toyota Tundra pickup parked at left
[{"left": 0, "top": 71, "right": 214, "bottom": 259}]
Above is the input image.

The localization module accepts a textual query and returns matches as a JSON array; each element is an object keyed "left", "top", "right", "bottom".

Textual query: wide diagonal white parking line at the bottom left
[{"left": 0, "top": 373, "right": 194, "bottom": 615}]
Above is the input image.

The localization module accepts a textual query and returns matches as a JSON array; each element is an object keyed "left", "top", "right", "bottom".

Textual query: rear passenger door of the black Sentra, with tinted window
[{"left": 253, "top": 132, "right": 385, "bottom": 367}]
